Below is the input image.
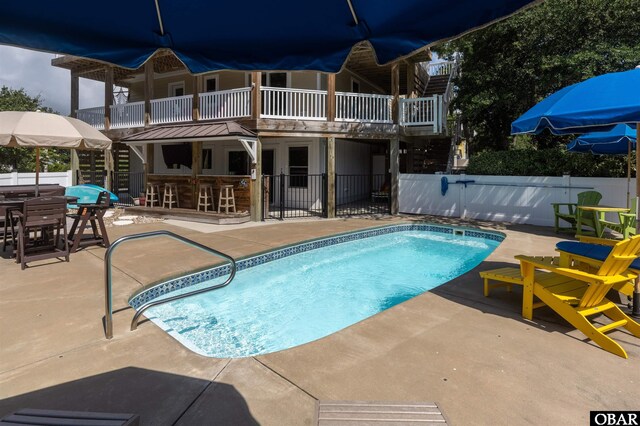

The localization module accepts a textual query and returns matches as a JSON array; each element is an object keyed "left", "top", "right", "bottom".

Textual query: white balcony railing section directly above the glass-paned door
[{"left": 260, "top": 87, "right": 327, "bottom": 120}]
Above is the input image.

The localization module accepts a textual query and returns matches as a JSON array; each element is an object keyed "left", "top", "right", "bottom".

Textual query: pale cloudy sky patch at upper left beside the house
[{"left": 0, "top": 46, "right": 104, "bottom": 115}]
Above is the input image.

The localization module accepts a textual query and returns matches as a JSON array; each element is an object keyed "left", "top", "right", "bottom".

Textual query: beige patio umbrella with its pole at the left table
[{"left": 0, "top": 111, "right": 111, "bottom": 194}]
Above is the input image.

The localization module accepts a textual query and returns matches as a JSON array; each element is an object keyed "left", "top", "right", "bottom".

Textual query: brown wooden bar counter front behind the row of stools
[{"left": 147, "top": 174, "right": 251, "bottom": 213}]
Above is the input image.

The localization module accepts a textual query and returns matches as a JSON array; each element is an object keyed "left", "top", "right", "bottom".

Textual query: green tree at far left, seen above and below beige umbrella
[{"left": 0, "top": 86, "right": 70, "bottom": 173}]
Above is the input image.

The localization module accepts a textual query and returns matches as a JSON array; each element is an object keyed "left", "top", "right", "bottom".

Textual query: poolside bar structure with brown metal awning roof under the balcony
[{"left": 122, "top": 122, "right": 260, "bottom": 223}]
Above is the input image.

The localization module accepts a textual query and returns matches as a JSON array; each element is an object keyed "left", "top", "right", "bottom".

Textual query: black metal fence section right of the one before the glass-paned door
[{"left": 336, "top": 174, "right": 391, "bottom": 217}]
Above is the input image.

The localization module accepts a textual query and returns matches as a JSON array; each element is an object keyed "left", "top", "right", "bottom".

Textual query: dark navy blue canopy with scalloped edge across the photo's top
[{"left": 0, "top": 0, "right": 535, "bottom": 73}]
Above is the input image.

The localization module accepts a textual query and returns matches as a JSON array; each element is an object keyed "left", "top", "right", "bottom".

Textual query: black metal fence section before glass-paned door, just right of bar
[{"left": 262, "top": 173, "right": 327, "bottom": 220}]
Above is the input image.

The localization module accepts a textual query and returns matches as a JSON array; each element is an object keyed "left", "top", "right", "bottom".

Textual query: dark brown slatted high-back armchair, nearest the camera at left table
[{"left": 10, "top": 197, "right": 69, "bottom": 269}]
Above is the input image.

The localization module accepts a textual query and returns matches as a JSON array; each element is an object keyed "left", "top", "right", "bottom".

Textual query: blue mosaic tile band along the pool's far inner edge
[{"left": 129, "top": 223, "right": 505, "bottom": 310}]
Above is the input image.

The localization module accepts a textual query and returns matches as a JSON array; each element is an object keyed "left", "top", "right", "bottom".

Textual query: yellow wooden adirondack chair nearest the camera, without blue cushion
[{"left": 516, "top": 236, "right": 640, "bottom": 358}]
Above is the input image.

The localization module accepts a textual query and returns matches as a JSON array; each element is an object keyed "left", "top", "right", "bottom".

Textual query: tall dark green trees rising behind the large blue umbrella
[{"left": 435, "top": 0, "right": 640, "bottom": 152}]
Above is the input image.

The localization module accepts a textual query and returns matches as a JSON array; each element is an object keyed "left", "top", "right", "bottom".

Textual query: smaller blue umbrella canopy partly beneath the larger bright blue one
[{"left": 567, "top": 124, "right": 637, "bottom": 154}]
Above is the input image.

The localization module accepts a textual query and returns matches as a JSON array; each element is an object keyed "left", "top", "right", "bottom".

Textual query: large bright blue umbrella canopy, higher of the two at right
[{"left": 511, "top": 68, "right": 640, "bottom": 135}]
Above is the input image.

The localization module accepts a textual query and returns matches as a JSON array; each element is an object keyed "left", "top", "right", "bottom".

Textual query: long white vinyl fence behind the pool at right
[{"left": 399, "top": 174, "right": 636, "bottom": 226}]
